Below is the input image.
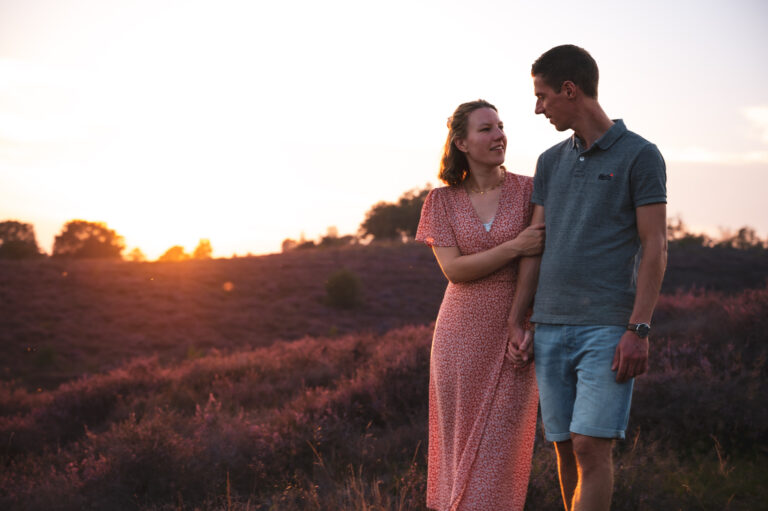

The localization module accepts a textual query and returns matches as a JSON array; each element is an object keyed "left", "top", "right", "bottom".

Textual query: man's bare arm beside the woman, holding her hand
[{"left": 507, "top": 204, "right": 544, "bottom": 363}]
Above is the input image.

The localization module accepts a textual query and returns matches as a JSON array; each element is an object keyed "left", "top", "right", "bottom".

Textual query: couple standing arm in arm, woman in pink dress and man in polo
[{"left": 416, "top": 45, "right": 666, "bottom": 511}]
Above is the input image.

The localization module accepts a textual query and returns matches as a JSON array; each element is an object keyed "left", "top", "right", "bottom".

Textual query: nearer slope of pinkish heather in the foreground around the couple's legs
[{"left": 0, "top": 289, "right": 768, "bottom": 511}]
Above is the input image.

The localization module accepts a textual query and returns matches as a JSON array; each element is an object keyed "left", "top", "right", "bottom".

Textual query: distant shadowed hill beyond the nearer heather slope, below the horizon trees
[{"left": 0, "top": 243, "right": 768, "bottom": 388}]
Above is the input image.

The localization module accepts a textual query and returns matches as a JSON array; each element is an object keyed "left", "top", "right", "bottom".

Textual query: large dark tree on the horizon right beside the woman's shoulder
[{"left": 360, "top": 185, "right": 431, "bottom": 240}]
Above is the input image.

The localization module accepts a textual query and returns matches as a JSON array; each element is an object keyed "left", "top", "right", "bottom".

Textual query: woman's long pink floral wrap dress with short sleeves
[{"left": 416, "top": 172, "right": 538, "bottom": 511}]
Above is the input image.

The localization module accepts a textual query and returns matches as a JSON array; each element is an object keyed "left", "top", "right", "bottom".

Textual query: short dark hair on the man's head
[{"left": 531, "top": 44, "right": 600, "bottom": 99}]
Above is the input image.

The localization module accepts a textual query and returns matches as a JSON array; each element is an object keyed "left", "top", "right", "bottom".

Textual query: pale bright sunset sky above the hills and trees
[{"left": 0, "top": 0, "right": 768, "bottom": 258}]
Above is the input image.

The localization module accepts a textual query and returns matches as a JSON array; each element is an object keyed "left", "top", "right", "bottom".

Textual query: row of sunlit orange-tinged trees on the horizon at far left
[{"left": 0, "top": 220, "right": 213, "bottom": 261}]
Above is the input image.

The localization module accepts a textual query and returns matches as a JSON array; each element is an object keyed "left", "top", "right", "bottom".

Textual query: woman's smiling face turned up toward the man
[{"left": 455, "top": 108, "right": 507, "bottom": 168}]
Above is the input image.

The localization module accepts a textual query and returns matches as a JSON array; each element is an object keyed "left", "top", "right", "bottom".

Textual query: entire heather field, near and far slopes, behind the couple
[{"left": 0, "top": 245, "right": 768, "bottom": 510}]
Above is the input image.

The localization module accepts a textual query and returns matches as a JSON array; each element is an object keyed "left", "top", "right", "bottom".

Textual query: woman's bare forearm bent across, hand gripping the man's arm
[{"left": 432, "top": 223, "right": 544, "bottom": 284}]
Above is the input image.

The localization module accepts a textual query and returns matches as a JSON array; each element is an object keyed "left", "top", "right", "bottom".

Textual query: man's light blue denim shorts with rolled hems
[{"left": 533, "top": 324, "right": 634, "bottom": 442}]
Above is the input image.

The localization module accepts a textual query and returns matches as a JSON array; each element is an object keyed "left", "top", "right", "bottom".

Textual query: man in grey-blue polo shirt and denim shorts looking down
[{"left": 509, "top": 45, "right": 667, "bottom": 511}]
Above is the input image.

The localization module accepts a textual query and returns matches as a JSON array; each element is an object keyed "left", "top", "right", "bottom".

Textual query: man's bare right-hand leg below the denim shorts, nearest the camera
[{"left": 558, "top": 433, "right": 613, "bottom": 511}]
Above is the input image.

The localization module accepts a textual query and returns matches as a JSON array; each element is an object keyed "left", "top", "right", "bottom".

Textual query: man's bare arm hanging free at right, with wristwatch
[{"left": 611, "top": 203, "right": 667, "bottom": 382}]
